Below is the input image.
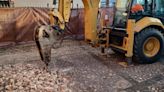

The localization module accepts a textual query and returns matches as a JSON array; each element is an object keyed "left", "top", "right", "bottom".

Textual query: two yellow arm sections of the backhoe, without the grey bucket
[{"left": 49, "top": 0, "right": 100, "bottom": 42}]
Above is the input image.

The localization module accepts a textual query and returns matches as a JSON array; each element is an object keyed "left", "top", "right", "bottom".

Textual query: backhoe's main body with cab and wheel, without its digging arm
[{"left": 99, "top": 0, "right": 164, "bottom": 64}]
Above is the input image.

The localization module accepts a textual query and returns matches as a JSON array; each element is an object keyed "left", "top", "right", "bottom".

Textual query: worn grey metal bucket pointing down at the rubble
[{"left": 34, "top": 25, "right": 60, "bottom": 66}]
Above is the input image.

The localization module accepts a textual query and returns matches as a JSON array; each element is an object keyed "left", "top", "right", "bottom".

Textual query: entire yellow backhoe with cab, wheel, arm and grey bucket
[{"left": 35, "top": 0, "right": 164, "bottom": 65}]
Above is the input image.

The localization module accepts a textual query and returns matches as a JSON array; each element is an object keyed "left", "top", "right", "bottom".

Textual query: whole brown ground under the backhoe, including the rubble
[{"left": 0, "top": 40, "right": 164, "bottom": 92}]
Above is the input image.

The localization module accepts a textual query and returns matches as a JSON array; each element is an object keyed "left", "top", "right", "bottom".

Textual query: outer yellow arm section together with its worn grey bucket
[{"left": 34, "top": 0, "right": 72, "bottom": 69}]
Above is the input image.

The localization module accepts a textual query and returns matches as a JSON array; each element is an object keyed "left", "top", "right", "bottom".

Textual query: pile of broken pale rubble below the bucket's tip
[{"left": 0, "top": 64, "right": 71, "bottom": 92}]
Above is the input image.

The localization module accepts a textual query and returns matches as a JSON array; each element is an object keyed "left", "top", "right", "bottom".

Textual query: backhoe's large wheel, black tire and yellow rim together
[{"left": 133, "top": 28, "right": 164, "bottom": 64}]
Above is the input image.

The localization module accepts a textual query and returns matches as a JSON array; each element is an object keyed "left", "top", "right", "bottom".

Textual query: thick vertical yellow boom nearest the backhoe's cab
[{"left": 82, "top": 0, "right": 100, "bottom": 43}]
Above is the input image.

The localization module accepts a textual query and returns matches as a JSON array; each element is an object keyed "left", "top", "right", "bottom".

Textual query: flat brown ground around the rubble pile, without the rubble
[{"left": 0, "top": 41, "right": 164, "bottom": 92}]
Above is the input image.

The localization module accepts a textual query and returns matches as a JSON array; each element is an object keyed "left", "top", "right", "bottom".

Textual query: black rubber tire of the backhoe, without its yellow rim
[{"left": 133, "top": 28, "right": 164, "bottom": 64}]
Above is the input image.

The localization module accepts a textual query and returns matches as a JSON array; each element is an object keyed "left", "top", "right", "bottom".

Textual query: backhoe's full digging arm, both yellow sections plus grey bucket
[{"left": 34, "top": 0, "right": 100, "bottom": 66}]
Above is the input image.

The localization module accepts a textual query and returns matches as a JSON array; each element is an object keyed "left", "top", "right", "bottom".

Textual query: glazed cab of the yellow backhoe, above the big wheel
[{"left": 112, "top": 0, "right": 164, "bottom": 28}]
